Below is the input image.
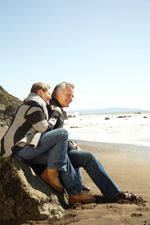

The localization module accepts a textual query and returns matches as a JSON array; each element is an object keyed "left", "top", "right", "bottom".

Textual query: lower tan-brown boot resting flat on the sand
[{"left": 69, "top": 191, "right": 96, "bottom": 205}]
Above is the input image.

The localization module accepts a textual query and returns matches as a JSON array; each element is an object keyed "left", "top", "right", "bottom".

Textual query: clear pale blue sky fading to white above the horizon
[{"left": 0, "top": 0, "right": 150, "bottom": 109}]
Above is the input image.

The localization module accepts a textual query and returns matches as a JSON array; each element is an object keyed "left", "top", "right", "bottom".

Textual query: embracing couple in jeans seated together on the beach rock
[{"left": 1, "top": 82, "right": 137, "bottom": 204}]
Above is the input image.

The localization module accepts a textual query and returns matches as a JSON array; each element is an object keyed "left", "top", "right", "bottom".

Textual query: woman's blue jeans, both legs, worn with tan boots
[{"left": 15, "top": 128, "right": 83, "bottom": 196}]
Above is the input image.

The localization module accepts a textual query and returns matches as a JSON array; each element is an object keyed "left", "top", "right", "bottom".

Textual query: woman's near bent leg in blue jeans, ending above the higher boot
[{"left": 16, "top": 128, "right": 68, "bottom": 170}]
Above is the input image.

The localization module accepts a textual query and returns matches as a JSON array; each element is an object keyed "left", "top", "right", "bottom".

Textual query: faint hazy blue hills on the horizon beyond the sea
[{"left": 67, "top": 107, "right": 145, "bottom": 115}]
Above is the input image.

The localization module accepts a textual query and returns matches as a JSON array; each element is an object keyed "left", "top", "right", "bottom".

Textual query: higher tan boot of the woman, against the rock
[{"left": 41, "top": 169, "right": 63, "bottom": 192}]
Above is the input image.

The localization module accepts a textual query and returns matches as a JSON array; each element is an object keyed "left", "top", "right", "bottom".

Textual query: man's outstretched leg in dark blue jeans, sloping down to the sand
[{"left": 68, "top": 150, "right": 121, "bottom": 199}]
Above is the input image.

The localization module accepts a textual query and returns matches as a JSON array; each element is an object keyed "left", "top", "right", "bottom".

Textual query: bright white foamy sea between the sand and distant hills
[{"left": 64, "top": 112, "right": 150, "bottom": 149}]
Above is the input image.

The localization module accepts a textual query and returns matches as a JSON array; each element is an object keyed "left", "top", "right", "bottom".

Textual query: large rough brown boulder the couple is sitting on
[{"left": 0, "top": 157, "right": 66, "bottom": 220}]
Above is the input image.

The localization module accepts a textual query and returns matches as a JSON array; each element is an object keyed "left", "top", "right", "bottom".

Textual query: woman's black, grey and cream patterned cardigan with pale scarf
[{"left": 0, "top": 93, "right": 59, "bottom": 157}]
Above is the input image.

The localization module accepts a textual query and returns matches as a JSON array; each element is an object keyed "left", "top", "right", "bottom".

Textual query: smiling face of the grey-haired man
[{"left": 56, "top": 86, "right": 74, "bottom": 108}]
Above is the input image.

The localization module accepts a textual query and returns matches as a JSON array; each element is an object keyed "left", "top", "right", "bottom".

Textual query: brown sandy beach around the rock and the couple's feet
[{"left": 0, "top": 128, "right": 150, "bottom": 225}]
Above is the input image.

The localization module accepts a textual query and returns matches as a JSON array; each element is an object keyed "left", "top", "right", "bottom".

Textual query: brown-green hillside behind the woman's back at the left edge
[{"left": 0, "top": 85, "right": 22, "bottom": 112}]
